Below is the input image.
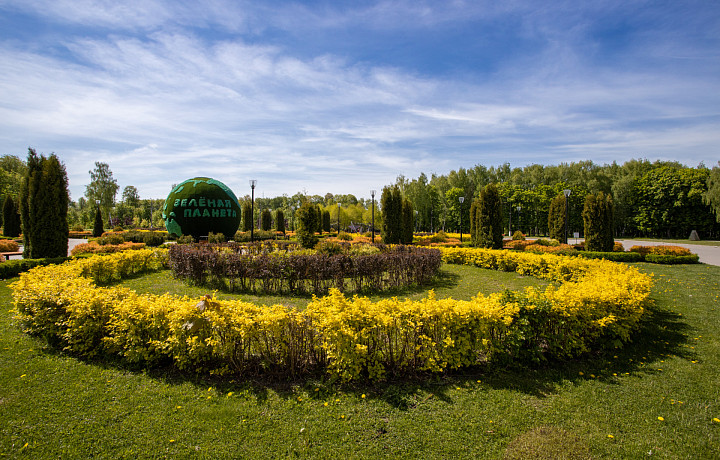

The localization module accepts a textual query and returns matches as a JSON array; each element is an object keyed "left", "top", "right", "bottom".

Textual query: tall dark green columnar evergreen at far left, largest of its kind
[{"left": 20, "top": 149, "right": 70, "bottom": 259}]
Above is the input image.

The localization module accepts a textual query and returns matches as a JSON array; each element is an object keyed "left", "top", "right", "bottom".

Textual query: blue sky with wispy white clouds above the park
[{"left": 0, "top": 0, "right": 720, "bottom": 200}]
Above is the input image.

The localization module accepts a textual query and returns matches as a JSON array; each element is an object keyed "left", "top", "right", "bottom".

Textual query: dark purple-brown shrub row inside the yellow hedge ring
[{"left": 169, "top": 243, "right": 442, "bottom": 294}]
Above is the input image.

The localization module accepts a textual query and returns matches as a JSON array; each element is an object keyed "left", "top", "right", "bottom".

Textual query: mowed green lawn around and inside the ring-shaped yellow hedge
[{"left": 0, "top": 264, "right": 720, "bottom": 459}]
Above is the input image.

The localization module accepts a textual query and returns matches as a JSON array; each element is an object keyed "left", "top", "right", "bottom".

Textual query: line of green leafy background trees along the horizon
[{"left": 0, "top": 151, "right": 720, "bottom": 243}]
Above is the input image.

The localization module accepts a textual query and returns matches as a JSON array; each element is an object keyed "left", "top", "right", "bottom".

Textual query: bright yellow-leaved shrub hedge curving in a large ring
[{"left": 12, "top": 249, "right": 651, "bottom": 380}]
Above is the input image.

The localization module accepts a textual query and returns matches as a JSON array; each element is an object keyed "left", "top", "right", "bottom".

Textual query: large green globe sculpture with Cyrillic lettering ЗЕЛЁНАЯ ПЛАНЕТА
[{"left": 163, "top": 177, "right": 241, "bottom": 240}]
